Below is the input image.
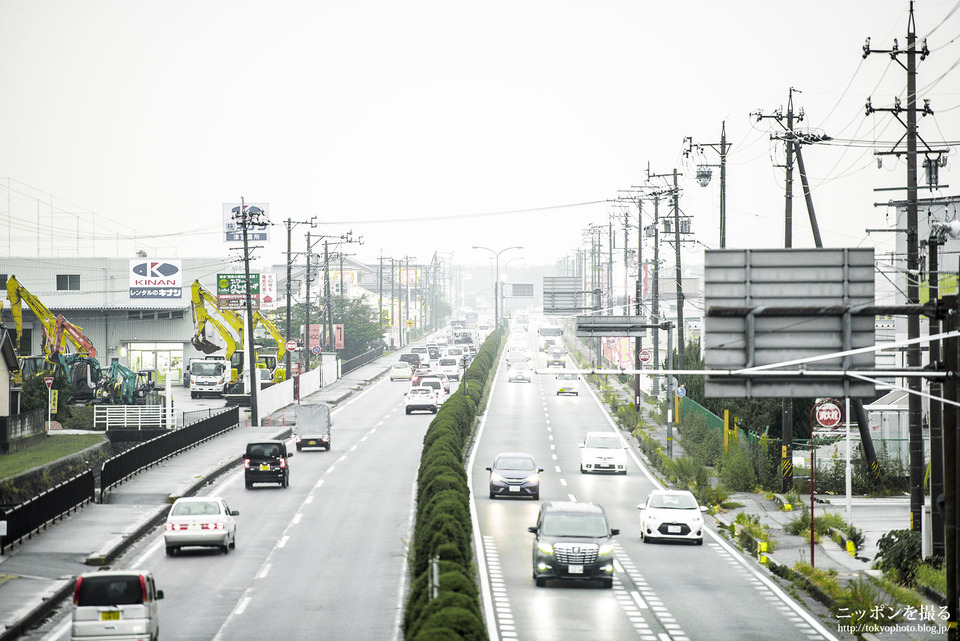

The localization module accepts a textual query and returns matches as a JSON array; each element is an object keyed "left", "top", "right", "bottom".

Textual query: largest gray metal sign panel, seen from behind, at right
[{"left": 703, "top": 248, "right": 875, "bottom": 398}]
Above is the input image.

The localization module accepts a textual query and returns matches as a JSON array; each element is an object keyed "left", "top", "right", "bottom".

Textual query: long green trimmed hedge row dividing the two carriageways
[{"left": 403, "top": 332, "right": 502, "bottom": 641}]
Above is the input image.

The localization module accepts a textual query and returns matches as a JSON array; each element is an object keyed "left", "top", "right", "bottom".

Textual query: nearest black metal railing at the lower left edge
[{"left": 0, "top": 470, "right": 96, "bottom": 554}]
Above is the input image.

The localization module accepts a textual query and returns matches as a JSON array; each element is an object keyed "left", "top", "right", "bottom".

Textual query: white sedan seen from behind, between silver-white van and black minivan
[{"left": 163, "top": 496, "right": 240, "bottom": 556}]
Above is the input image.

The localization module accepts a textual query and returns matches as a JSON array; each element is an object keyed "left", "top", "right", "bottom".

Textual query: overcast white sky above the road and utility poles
[{"left": 0, "top": 0, "right": 960, "bottom": 276}]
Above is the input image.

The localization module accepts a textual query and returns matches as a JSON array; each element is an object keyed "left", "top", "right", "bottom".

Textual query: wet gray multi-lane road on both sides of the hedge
[{"left": 31, "top": 334, "right": 833, "bottom": 641}]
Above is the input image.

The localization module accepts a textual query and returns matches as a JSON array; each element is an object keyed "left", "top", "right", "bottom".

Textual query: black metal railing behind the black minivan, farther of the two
[{"left": 100, "top": 407, "right": 240, "bottom": 503}]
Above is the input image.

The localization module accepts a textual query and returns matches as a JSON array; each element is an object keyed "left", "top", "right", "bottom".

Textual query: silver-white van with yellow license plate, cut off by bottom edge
[{"left": 70, "top": 570, "right": 163, "bottom": 641}]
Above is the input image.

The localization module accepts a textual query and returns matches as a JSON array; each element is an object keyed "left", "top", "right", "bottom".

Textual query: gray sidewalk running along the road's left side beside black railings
[{"left": 0, "top": 353, "right": 397, "bottom": 641}]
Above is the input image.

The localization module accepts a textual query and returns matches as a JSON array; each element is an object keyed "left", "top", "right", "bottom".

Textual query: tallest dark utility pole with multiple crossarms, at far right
[{"left": 863, "top": 0, "right": 932, "bottom": 536}]
